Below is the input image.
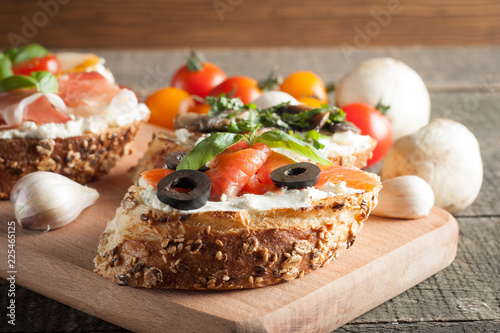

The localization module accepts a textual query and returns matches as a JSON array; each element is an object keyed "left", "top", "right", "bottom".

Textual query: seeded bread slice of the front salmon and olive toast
[{"left": 94, "top": 186, "right": 378, "bottom": 290}]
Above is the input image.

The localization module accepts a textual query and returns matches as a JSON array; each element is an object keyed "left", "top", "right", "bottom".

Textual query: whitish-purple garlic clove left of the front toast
[{"left": 10, "top": 171, "right": 99, "bottom": 231}]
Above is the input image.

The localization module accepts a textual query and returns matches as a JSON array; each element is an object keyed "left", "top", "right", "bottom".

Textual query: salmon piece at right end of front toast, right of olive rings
[{"left": 314, "top": 164, "right": 382, "bottom": 191}]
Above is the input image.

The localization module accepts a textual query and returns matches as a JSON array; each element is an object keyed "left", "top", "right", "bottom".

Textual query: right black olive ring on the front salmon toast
[{"left": 271, "top": 162, "right": 321, "bottom": 190}]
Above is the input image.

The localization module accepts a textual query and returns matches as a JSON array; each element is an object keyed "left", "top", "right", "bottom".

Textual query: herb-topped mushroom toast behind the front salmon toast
[{"left": 129, "top": 91, "right": 376, "bottom": 184}]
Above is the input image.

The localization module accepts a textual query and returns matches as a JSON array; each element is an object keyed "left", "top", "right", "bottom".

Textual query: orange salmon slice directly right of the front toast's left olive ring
[{"left": 205, "top": 142, "right": 272, "bottom": 201}]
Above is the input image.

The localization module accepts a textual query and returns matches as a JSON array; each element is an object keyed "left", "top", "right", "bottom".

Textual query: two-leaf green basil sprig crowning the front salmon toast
[{"left": 176, "top": 129, "right": 332, "bottom": 170}]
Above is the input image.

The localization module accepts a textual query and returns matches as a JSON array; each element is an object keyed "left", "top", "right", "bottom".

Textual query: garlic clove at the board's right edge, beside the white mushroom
[{"left": 372, "top": 176, "right": 434, "bottom": 219}]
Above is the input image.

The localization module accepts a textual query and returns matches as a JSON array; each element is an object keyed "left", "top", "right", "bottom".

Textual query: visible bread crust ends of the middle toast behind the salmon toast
[{"left": 128, "top": 131, "right": 377, "bottom": 184}]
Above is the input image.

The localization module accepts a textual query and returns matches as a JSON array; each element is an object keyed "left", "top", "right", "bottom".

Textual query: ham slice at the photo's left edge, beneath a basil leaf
[{"left": 0, "top": 91, "right": 71, "bottom": 129}]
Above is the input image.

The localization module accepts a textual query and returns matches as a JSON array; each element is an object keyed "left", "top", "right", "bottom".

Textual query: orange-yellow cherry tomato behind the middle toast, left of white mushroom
[{"left": 280, "top": 71, "right": 328, "bottom": 104}]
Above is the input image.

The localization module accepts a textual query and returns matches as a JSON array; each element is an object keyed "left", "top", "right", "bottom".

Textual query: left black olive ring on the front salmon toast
[{"left": 156, "top": 170, "right": 212, "bottom": 210}]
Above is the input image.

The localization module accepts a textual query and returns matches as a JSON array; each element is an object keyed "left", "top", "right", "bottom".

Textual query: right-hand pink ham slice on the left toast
[{"left": 59, "top": 72, "right": 121, "bottom": 111}]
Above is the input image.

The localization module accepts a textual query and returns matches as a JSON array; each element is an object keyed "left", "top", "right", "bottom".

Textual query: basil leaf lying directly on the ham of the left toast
[{"left": 0, "top": 71, "right": 58, "bottom": 93}]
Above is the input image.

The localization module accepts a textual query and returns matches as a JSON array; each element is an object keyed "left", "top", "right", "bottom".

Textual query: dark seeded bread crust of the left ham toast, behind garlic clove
[{"left": 0, "top": 121, "right": 142, "bottom": 199}]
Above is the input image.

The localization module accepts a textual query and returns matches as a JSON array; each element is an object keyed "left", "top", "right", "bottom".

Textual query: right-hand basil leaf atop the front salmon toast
[{"left": 254, "top": 130, "right": 332, "bottom": 165}]
